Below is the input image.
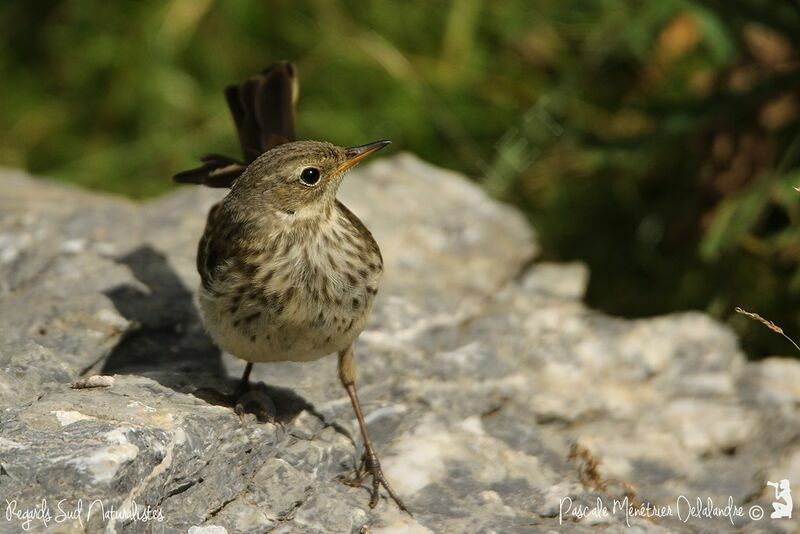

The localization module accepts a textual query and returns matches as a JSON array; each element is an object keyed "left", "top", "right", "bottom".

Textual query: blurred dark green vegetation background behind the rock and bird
[{"left": 0, "top": 0, "right": 800, "bottom": 357}]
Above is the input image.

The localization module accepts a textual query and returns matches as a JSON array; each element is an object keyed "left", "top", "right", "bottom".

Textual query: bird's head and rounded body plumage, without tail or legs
[{"left": 197, "top": 141, "right": 390, "bottom": 362}]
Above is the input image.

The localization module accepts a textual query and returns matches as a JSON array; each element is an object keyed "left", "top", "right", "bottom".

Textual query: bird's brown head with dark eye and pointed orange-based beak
[{"left": 231, "top": 141, "right": 390, "bottom": 217}]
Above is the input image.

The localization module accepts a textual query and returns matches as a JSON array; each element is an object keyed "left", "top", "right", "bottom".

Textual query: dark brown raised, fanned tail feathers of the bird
[{"left": 172, "top": 62, "right": 298, "bottom": 187}]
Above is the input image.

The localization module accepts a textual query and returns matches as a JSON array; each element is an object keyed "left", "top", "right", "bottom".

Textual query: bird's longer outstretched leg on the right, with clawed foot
[{"left": 339, "top": 345, "right": 411, "bottom": 514}]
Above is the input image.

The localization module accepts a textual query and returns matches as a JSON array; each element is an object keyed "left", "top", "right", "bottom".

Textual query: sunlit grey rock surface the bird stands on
[{"left": 0, "top": 155, "right": 800, "bottom": 534}]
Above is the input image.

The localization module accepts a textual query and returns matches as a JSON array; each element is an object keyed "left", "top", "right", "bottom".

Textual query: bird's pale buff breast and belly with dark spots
[{"left": 201, "top": 216, "right": 383, "bottom": 361}]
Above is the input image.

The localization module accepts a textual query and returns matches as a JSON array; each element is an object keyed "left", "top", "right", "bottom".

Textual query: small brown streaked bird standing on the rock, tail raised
[{"left": 174, "top": 62, "right": 410, "bottom": 514}]
